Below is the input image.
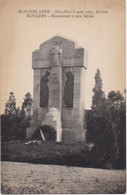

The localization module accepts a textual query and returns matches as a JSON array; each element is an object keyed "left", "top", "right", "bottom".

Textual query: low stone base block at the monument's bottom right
[{"left": 62, "top": 128, "right": 87, "bottom": 144}]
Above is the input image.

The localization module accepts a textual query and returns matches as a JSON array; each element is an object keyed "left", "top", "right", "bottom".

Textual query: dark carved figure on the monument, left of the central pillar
[{"left": 40, "top": 70, "right": 50, "bottom": 107}]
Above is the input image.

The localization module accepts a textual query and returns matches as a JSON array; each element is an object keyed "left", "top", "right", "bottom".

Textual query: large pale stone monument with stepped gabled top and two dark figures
[{"left": 26, "top": 36, "right": 87, "bottom": 143}]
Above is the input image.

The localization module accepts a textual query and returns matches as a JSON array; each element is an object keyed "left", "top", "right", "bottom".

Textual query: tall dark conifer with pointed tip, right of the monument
[{"left": 87, "top": 69, "right": 122, "bottom": 168}]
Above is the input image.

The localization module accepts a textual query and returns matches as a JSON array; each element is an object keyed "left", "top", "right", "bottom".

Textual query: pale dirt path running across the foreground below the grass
[{"left": 1, "top": 162, "right": 125, "bottom": 194}]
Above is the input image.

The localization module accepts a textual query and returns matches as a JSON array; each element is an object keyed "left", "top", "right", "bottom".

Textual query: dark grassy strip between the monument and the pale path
[{"left": 2, "top": 141, "right": 106, "bottom": 168}]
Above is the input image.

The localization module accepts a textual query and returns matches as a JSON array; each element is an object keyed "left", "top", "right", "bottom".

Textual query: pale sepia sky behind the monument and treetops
[{"left": 0, "top": 0, "right": 125, "bottom": 113}]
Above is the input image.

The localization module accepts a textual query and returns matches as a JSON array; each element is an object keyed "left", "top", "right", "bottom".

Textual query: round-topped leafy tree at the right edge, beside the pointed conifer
[{"left": 108, "top": 91, "right": 126, "bottom": 168}]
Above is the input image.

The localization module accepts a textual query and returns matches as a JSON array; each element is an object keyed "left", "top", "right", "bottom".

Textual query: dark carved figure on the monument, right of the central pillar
[{"left": 64, "top": 72, "right": 74, "bottom": 107}]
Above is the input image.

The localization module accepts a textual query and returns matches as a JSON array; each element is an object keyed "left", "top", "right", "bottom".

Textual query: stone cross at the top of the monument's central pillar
[{"left": 51, "top": 46, "right": 62, "bottom": 65}]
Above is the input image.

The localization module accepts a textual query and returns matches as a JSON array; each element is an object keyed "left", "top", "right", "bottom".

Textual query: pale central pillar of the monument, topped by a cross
[{"left": 42, "top": 46, "right": 62, "bottom": 142}]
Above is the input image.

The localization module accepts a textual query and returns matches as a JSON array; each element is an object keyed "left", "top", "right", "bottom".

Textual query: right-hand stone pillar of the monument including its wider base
[{"left": 62, "top": 66, "right": 86, "bottom": 143}]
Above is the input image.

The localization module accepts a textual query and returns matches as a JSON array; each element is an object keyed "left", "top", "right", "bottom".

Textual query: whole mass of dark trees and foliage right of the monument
[{"left": 87, "top": 70, "right": 126, "bottom": 168}]
